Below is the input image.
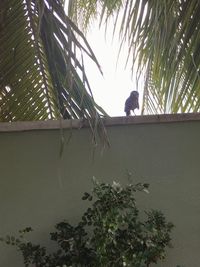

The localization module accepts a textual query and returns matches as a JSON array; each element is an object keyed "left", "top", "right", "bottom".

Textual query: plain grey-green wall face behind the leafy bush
[{"left": 0, "top": 115, "right": 200, "bottom": 267}]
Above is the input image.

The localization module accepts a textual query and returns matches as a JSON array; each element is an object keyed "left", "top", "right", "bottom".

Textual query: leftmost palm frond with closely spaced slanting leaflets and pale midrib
[{"left": 0, "top": 0, "right": 56, "bottom": 121}]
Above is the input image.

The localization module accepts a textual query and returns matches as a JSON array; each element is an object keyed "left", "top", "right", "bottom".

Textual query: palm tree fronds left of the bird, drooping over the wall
[{"left": 0, "top": 0, "right": 109, "bottom": 143}]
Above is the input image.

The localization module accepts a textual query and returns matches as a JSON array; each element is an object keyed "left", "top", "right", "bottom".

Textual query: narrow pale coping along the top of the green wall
[{"left": 0, "top": 113, "right": 200, "bottom": 132}]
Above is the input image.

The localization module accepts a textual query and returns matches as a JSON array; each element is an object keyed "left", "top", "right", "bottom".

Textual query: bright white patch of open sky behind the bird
[{"left": 81, "top": 25, "right": 142, "bottom": 116}]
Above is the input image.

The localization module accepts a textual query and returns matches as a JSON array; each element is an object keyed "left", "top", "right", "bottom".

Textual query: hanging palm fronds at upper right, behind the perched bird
[{"left": 68, "top": 0, "right": 200, "bottom": 114}]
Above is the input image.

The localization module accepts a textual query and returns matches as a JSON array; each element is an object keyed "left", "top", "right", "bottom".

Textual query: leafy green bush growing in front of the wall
[{"left": 1, "top": 181, "right": 173, "bottom": 267}]
